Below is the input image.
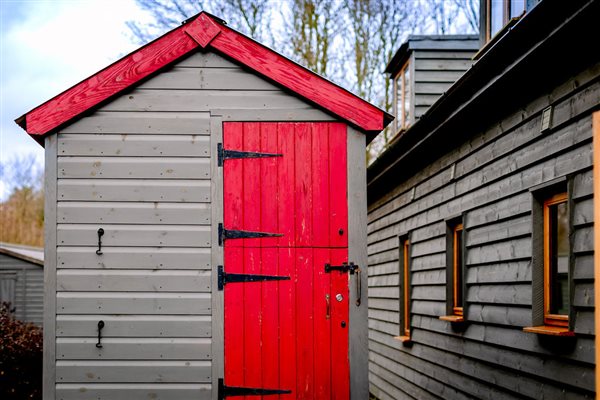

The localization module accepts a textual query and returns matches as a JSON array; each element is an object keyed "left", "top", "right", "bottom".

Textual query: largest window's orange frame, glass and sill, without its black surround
[{"left": 523, "top": 193, "right": 574, "bottom": 336}]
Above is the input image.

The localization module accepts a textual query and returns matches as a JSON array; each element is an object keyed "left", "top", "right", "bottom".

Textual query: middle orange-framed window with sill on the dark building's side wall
[{"left": 440, "top": 221, "right": 465, "bottom": 322}]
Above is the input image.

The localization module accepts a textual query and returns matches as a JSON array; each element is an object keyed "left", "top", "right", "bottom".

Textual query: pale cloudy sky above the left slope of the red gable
[{"left": 0, "top": 0, "right": 149, "bottom": 199}]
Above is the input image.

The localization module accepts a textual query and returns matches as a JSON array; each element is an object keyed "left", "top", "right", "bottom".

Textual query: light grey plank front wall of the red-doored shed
[{"left": 44, "top": 53, "right": 338, "bottom": 400}]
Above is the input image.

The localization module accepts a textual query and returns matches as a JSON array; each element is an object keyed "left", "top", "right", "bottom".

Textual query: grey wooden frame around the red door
[{"left": 210, "top": 113, "right": 369, "bottom": 400}]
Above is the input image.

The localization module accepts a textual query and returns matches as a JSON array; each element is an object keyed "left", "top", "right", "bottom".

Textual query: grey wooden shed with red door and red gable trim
[{"left": 17, "top": 13, "right": 391, "bottom": 400}]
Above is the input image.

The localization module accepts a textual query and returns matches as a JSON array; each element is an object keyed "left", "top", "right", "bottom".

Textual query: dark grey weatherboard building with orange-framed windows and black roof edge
[{"left": 367, "top": 0, "right": 600, "bottom": 400}]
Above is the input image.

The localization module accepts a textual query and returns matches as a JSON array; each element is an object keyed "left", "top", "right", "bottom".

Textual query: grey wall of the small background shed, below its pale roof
[{"left": 0, "top": 249, "right": 44, "bottom": 327}]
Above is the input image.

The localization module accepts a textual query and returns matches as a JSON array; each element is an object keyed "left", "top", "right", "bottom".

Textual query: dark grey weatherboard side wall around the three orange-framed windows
[{"left": 368, "top": 60, "right": 600, "bottom": 400}]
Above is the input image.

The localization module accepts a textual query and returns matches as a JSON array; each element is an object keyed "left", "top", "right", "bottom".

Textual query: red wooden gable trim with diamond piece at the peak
[{"left": 17, "top": 13, "right": 392, "bottom": 141}]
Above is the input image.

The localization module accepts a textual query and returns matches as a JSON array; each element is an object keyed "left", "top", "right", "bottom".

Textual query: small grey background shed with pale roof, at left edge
[{"left": 0, "top": 243, "right": 44, "bottom": 327}]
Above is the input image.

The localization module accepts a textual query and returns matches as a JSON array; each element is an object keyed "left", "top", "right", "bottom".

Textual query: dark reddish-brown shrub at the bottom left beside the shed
[{"left": 0, "top": 303, "right": 43, "bottom": 400}]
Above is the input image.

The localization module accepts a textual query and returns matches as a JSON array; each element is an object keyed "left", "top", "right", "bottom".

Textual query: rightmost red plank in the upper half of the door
[{"left": 328, "top": 123, "right": 348, "bottom": 247}]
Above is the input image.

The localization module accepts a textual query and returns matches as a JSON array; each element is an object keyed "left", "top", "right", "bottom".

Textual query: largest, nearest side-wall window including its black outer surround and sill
[{"left": 523, "top": 180, "right": 574, "bottom": 336}]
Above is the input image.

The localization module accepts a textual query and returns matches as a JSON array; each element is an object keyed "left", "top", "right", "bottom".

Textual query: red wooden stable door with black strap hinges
[{"left": 223, "top": 122, "right": 349, "bottom": 400}]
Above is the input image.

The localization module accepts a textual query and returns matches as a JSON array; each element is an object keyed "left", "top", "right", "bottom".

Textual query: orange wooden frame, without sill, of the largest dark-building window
[{"left": 542, "top": 191, "right": 572, "bottom": 327}]
